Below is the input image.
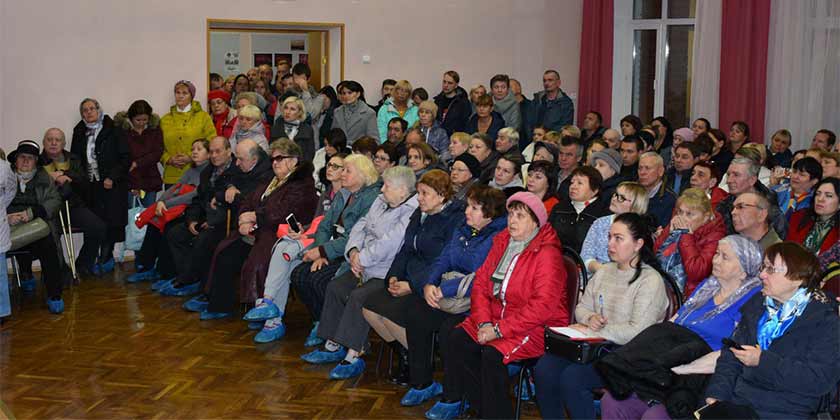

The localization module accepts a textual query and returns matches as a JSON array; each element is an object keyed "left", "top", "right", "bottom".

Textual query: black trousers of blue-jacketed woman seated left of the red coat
[{"left": 405, "top": 293, "right": 466, "bottom": 388}]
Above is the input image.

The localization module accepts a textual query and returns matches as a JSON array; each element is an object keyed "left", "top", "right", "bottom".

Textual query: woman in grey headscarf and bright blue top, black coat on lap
[{"left": 598, "top": 235, "right": 762, "bottom": 419}]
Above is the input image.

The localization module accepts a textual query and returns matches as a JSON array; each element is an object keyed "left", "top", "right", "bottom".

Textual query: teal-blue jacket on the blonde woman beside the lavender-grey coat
[{"left": 307, "top": 182, "right": 382, "bottom": 261}]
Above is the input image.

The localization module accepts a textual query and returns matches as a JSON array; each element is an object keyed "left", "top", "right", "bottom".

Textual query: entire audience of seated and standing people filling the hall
[{"left": 0, "top": 63, "right": 840, "bottom": 419}]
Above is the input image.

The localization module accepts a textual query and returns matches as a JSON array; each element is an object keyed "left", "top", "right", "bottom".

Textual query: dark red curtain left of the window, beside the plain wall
[{"left": 577, "top": 0, "right": 613, "bottom": 127}]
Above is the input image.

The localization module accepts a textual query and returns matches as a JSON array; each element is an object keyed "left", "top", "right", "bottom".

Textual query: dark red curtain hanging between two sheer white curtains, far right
[{"left": 719, "top": 0, "right": 771, "bottom": 143}]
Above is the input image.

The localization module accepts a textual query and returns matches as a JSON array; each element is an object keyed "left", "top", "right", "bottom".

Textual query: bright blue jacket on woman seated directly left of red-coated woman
[{"left": 426, "top": 216, "right": 507, "bottom": 297}]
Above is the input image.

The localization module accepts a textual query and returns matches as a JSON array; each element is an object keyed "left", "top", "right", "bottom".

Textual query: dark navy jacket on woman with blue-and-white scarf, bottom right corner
[{"left": 706, "top": 291, "right": 840, "bottom": 419}]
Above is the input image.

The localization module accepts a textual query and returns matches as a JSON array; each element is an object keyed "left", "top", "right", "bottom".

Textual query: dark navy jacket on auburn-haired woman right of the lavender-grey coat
[{"left": 385, "top": 201, "right": 464, "bottom": 295}]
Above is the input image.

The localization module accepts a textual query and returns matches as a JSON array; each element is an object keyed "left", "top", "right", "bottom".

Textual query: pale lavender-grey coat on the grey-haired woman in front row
[{"left": 336, "top": 194, "right": 418, "bottom": 281}]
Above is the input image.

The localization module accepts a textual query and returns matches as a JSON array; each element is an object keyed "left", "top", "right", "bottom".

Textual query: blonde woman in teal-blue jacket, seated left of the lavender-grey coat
[{"left": 288, "top": 155, "right": 382, "bottom": 347}]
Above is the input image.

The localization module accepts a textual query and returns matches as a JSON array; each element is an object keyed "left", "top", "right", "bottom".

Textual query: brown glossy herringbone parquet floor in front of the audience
[{"left": 0, "top": 269, "right": 538, "bottom": 419}]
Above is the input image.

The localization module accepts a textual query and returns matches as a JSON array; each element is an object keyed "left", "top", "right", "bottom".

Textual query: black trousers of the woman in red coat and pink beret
[{"left": 444, "top": 328, "right": 513, "bottom": 419}]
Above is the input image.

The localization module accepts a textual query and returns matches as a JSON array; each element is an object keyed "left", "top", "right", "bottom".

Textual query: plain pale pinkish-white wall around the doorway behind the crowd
[{"left": 0, "top": 0, "right": 583, "bottom": 151}]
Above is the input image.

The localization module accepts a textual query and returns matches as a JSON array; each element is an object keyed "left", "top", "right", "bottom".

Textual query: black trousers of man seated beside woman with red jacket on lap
[{"left": 166, "top": 223, "right": 225, "bottom": 284}]
